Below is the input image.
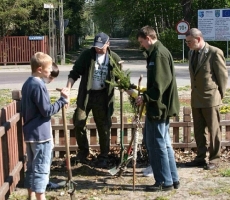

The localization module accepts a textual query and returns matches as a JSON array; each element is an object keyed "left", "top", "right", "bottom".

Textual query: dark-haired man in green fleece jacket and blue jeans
[{"left": 136, "top": 26, "right": 180, "bottom": 192}]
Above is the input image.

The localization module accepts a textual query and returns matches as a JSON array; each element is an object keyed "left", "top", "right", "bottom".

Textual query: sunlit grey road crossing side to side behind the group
[{"left": 0, "top": 61, "right": 230, "bottom": 89}]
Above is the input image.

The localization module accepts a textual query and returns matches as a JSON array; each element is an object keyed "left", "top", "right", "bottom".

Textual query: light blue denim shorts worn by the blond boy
[{"left": 25, "top": 140, "right": 53, "bottom": 193}]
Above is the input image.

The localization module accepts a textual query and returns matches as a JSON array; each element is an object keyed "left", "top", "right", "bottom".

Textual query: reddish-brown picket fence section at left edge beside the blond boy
[{"left": 0, "top": 101, "right": 25, "bottom": 200}]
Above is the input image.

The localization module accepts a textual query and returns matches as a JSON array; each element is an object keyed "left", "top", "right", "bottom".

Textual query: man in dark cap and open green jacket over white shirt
[{"left": 66, "top": 32, "right": 121, "bottom": 168}]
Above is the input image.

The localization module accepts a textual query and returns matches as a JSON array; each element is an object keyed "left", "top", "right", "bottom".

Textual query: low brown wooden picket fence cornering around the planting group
[{"left": 0, "top": 91, "right": 230, "bottom": 200}]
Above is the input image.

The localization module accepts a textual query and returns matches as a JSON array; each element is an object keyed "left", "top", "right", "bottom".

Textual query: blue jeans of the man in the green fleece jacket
[{"left": 145, "top": 117, "right": 179, "bottom": 186}]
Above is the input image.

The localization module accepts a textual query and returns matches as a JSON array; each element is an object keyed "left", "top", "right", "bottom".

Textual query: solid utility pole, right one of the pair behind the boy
[{"left": 59, "top": 0, "right": 65, "bottom": 65}]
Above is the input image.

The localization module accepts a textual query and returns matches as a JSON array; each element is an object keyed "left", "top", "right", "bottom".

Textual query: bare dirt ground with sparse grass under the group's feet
[{"left": 10, "top": 149, "right": 230, "bottom": 200}]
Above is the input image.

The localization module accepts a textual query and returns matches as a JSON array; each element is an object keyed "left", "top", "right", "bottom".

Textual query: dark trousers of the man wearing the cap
[{"left": 73, "top": 89, "right": 111, "bottom": 157}]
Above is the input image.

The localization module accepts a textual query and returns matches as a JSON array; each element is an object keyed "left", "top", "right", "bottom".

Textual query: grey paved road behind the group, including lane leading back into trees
[{"left": 0, "top": 38, "right": 230, "bottom": 89}]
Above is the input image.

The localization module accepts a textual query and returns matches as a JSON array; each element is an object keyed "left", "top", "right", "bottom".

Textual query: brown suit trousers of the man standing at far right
[{"left": 192, "top": 106, "right": 221, "bottom": 162}]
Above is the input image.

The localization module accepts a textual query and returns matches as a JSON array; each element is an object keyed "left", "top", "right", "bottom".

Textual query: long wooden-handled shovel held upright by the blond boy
[{"left": 56, "top": 88, "right": 77, "bottom": 200}]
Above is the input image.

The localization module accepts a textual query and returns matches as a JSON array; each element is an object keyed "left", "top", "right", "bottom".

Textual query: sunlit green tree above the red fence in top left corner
[{"left": 0, "top": 0, "right": 57, "bottom": 36}]
